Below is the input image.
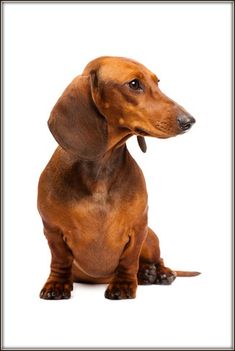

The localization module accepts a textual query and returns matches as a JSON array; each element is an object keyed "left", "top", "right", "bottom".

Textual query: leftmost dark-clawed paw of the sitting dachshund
[{"left": 40, "top": 282, "right": 73, "bottom": 300}]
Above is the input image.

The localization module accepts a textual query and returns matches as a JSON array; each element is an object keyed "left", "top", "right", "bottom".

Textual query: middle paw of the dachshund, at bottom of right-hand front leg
[{"left": 105, "top": 281, "right": 137, "bottom": 300}]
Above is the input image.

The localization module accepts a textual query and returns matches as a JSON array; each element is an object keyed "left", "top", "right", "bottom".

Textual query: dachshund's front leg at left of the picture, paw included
[{"left": 40, "top": 226, "right": 73, "bottom": 300}]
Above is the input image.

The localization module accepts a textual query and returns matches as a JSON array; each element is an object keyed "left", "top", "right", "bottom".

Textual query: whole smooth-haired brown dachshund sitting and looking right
[{"left": 38, "top": 57, "right": 199, "bottom": 300}]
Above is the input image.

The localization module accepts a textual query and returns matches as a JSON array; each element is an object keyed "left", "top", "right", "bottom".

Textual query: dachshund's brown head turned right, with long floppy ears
[{"left": 48, "top": 56, "right": 195, "bottom": 160}]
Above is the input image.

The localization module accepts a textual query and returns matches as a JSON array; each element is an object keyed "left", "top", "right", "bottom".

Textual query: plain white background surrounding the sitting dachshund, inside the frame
[{"left": 3, "top": 2, "right": 232, "bottom": 348}]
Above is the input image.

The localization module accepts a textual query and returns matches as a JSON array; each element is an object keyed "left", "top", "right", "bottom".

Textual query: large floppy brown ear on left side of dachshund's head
[{"left": 48, "top": 76, "right": 107, "bottom": 161}]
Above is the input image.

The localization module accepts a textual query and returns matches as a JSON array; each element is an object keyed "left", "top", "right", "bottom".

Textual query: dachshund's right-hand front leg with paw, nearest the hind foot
[{"left": 105, "top": 229, "right": 147, "bottom": 300}]
